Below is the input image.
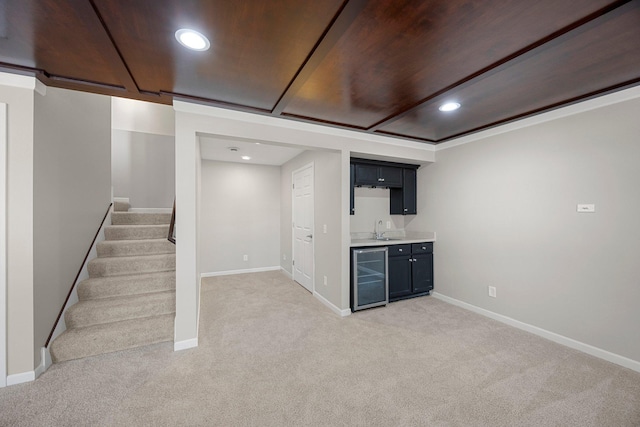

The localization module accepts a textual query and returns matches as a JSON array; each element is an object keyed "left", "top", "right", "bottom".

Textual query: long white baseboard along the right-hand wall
[{"left": 431, "top": 292, "right": 640, "bottom": 372}]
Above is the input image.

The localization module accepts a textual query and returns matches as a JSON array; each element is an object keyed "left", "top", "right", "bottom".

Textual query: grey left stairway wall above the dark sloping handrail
[{"left": 33, "top": 88, "right": 111, "bottom": 366}]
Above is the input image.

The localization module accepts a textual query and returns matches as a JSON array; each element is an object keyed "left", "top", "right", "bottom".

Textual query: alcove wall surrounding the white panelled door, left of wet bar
[{"left": 280, "top": 151, "right": 348, "bottom": 308}]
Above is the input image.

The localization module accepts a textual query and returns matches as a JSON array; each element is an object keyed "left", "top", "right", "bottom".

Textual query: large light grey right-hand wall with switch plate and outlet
[{"left": 410, "top": 93, "right": 640, "bottom": 361}]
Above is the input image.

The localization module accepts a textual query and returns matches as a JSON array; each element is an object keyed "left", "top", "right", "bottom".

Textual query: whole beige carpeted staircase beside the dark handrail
[{"left": 50, "top": 202, "right": 176, "bottom": 362}]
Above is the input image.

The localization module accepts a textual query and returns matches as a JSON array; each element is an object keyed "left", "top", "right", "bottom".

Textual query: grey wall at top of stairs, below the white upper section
[{"left": 111, "top": 131, "right": 175, "bottom": 208}]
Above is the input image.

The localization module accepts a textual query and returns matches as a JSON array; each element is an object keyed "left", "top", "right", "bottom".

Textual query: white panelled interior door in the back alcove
[{"left": 292, "top": 163, "right": 313, "bottom": 292}]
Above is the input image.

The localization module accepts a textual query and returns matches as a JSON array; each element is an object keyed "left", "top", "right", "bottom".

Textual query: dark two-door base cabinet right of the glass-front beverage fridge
[{"left": 388, "top": 242, "right": 433, "bottom": 302}]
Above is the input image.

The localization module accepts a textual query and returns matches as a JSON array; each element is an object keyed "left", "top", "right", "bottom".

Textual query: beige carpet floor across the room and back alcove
[{"left": 0, "top": 272, "right": 640, "bottom": 427}]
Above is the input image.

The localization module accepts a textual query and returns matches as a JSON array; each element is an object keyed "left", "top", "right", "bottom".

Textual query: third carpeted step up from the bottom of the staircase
[{"left": 78, "top": 271, "right": 176, "bottom": 301}]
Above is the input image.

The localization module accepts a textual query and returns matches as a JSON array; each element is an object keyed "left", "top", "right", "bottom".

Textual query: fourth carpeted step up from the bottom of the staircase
[{"left": 88, "top": 254, "right": 176, "bottom": 277}]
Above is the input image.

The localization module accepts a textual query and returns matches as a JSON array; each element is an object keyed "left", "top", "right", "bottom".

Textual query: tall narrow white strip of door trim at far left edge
[{"left": 0, "top": 103, "right": 7, "bottom": 387}]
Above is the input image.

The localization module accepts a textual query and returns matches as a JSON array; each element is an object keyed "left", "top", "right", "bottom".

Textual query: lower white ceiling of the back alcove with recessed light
[{"left": 199, "top": 135, "right": 305, "bottom": 166}]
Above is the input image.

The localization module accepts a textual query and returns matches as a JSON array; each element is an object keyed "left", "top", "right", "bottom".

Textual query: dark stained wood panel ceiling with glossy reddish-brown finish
[{"left": 0, "top": 0, "right": 640, "bottom": 144}]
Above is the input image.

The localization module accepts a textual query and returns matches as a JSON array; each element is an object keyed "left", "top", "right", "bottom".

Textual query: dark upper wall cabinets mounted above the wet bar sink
[{"left": 349, "top": 158, "right": 420, "bottom": 215}]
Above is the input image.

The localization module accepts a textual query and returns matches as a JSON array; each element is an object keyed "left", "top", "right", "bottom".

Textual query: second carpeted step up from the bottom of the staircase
[{"left": 64, "top": 291, "right": 176, "bottom": 328}]
